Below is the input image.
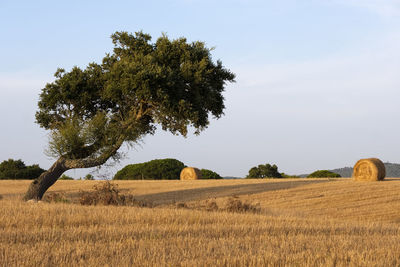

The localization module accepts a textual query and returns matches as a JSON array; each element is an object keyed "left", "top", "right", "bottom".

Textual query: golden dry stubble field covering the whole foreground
[{"left": 0, "top": 179, "right": 400, "bottom": 266}]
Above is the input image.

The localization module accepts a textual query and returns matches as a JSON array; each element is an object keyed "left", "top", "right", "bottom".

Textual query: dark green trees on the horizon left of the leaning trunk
[{"left": 0, "top": 159, "right": 45, "bottom": 180}]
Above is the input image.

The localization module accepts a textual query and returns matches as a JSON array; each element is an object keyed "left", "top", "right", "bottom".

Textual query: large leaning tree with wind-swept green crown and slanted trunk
[{"left": 24, "top": 32, "right": 235, "bottom": 200}]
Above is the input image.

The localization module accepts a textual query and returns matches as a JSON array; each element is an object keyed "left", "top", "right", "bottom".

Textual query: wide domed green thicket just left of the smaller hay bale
[{"left": 113, "top": 159, "right": 185, "bottom": 180}]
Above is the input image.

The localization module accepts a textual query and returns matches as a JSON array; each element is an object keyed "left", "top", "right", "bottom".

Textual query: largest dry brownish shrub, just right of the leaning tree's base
[{"left": 79, "top": 181, "right": 152, "bottom": 207}]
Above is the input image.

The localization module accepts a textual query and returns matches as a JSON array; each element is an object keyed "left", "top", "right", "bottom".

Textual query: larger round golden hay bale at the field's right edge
[{"left": 353, "top": 158, "right": 386, "bottom": 181}]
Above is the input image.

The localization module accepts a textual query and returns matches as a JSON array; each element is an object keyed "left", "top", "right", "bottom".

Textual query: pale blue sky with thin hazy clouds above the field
[{"left": 0, "top": 0, "right": 400, "bottom": 178}]
